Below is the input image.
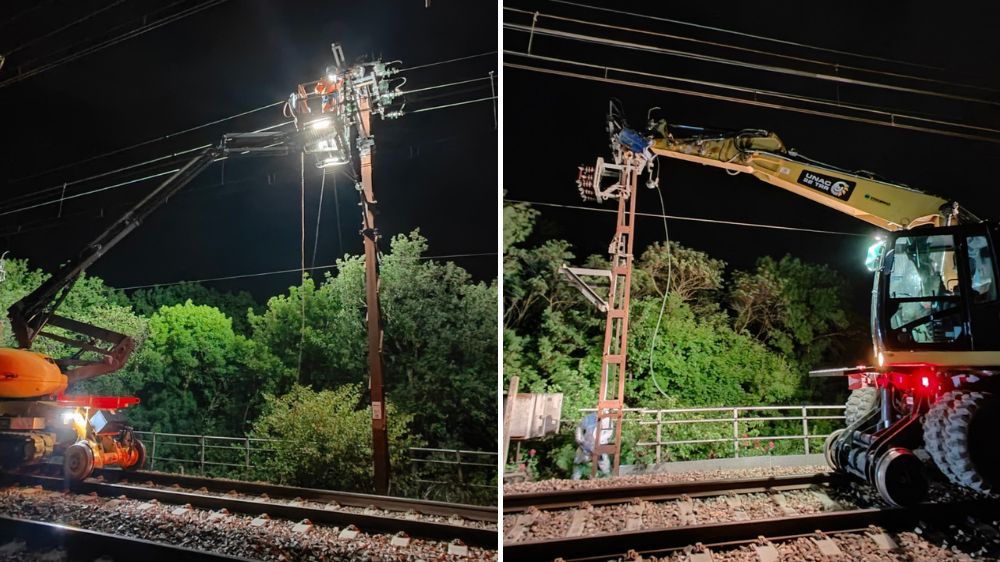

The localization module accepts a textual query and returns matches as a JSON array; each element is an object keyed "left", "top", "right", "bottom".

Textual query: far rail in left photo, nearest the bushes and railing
[{"left": 94, "top": 469, "right": 497, "bottom": 523}]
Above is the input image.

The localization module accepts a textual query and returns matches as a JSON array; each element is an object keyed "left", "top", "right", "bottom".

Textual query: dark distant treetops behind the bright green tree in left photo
[{"left": 129, "top": 282, "right": 258, "bottom": 336}]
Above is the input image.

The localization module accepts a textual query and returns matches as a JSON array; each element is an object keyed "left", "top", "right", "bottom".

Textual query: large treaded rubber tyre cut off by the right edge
[{"left": 943, "top": 392, "right": 1000, "bottom": 492}]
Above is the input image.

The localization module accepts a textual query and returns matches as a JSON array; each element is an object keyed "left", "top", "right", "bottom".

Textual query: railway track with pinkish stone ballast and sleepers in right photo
[{"left": 503, "top": 473, "right": 1000, "bottom": 562}]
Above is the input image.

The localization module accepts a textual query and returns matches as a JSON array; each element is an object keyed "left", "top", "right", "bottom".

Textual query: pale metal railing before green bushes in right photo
[{"left": 580, "top": 405, "right": 846, "bottom": 463}]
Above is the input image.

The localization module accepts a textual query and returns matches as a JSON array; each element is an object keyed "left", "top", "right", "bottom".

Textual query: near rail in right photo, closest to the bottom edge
[{"left": 503, "top": 499, "right": 1000, "bottom": 562}]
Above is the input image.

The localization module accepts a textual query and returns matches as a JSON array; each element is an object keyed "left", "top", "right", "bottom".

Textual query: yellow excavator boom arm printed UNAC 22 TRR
[{"left": 619, "top": 121, "right": 978, "bottom": 231}]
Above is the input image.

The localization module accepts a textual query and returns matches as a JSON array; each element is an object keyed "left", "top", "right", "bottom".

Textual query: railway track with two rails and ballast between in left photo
[{"left": 8, "top": 470, "right": 498, "bottom": 550}]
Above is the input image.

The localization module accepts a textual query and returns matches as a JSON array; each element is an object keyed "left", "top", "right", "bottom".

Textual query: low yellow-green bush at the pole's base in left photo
[{"left": 253, "top": 384, "right": 423, "bottom": 494}]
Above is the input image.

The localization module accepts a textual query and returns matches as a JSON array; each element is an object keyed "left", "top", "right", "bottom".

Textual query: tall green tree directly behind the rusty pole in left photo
[{"left": 250, "top": 232, "right": 497, "bottom": 447}]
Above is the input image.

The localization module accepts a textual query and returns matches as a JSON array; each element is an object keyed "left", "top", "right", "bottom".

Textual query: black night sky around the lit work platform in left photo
[{"left": 0, "top": 0, "right": 497, "bottom": 299}]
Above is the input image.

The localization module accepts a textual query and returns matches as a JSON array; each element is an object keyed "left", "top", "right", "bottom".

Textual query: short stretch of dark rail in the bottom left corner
[{"left": 0, "top": 515, "right": 254, "bottom": 562}]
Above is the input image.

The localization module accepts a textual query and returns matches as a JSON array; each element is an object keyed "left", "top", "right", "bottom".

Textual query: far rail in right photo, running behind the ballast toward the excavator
[{"left": 503, "top": 472, "right": 848, "bottom": 514}]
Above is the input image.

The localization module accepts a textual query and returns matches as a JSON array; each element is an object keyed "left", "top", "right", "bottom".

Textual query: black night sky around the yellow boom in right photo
[{"left": 503, "top": 0, "right": 1000, "bottom": 352}]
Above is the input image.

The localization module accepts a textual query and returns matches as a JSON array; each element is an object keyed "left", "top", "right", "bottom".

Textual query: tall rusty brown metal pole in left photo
[{"left": 358, "top": 96, "right": 389, "bottom": 494}]
